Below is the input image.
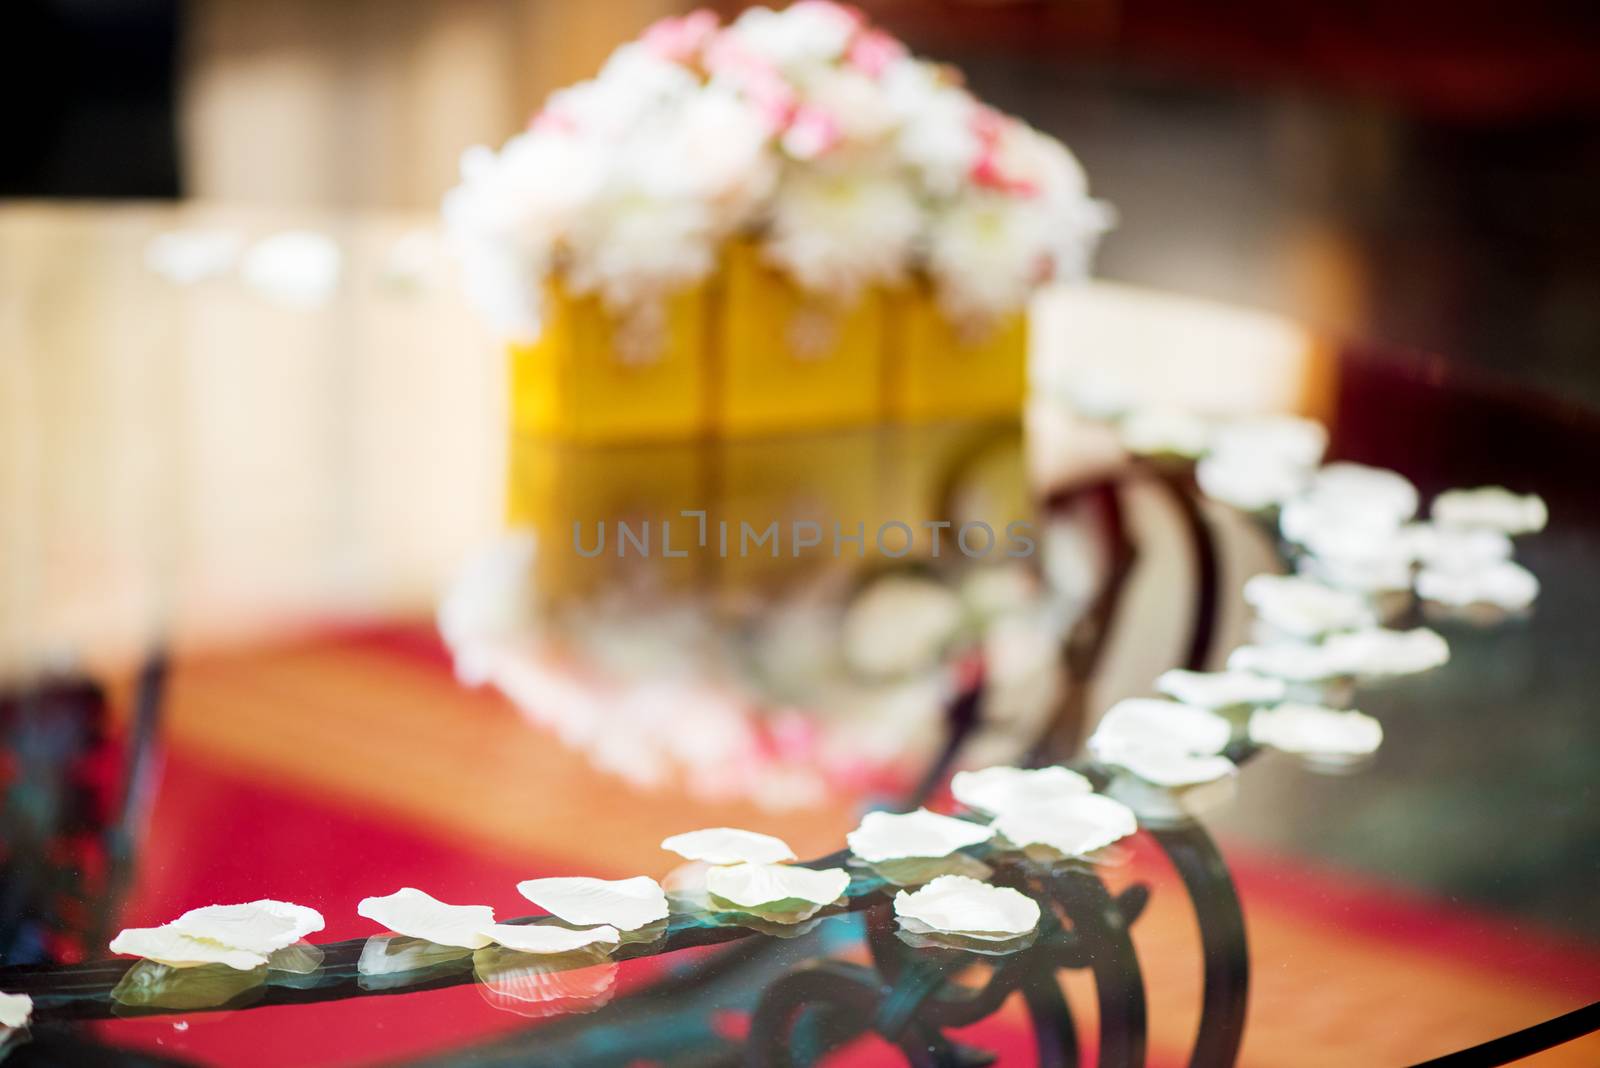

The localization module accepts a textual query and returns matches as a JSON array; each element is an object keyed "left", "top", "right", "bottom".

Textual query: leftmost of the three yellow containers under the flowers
[{"left": 510, "top": 281, "right": 710, "bottom": 444}]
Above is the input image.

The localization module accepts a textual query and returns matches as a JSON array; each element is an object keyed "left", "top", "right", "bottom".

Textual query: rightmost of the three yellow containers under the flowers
[{"left": 885, "top": 286, "right": 1027, "bottom": 422}]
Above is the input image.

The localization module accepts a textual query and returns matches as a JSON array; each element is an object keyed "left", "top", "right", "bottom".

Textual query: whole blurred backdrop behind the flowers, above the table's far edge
[{"left": 9, "top": 0, "right": 1600, "bottom": 401}]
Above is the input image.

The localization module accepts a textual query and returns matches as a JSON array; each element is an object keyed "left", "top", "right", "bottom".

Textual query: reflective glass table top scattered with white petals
[{"left": 0, "top": 206, "right": 1600, "bottom": 1065}]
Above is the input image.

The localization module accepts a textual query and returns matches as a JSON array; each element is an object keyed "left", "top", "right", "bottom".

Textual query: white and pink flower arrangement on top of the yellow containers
[{"left": 445, "top": 0, "right": 1109, "bottom": 336}]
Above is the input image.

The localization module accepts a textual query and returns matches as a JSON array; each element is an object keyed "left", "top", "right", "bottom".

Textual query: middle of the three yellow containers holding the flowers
[{"left": 714, "top": 241, "right": 888, "bottom": 436}]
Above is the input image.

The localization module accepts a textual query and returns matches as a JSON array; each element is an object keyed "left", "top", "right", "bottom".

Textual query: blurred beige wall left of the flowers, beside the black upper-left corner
[{"left": 181, "top": 0, "right": 688, "bottom": 206}]
